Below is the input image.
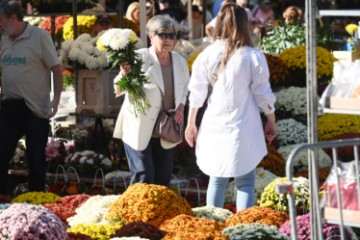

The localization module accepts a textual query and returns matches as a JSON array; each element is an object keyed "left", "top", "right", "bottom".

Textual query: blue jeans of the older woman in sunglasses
[{"left": 124, "top": 138, "right": 174, "bottom": 187}]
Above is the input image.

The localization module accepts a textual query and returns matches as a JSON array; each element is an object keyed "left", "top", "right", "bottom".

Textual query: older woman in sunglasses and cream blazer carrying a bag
[{"left": 114, "top": 15, "right": 189, "bottom": 186}]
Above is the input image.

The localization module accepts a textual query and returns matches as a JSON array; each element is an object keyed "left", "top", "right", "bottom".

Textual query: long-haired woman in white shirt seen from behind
[{"left": 185, "top": 3, "right": 276, "bottom": 211}]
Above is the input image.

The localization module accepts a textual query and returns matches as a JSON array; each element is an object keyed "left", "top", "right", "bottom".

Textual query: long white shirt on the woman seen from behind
[{"left": 189, "top": 40, "right": 275, "bottom": 177}]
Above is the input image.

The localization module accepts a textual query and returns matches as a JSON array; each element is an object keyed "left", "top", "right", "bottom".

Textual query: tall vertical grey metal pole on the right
[{"left": 305, "top": 0, "right": 323, "bottom": 240}]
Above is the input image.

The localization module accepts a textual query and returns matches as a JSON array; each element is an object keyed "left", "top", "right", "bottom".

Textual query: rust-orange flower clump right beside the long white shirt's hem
[{"left": 257, "top": 145, "right": 285, "bottom": 177}]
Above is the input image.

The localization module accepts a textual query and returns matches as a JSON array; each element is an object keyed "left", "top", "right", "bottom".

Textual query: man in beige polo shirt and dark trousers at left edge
[{"left": 0, "top": 0, "right": 63, "bottom": 194}]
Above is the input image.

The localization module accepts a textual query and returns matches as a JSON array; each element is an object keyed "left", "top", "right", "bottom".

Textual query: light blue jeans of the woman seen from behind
[{"left": 206, "top": 169, "right": 256, "bottom": 211}]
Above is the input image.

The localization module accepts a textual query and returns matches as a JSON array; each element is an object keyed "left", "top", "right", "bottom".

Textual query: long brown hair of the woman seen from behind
[{"left": 214, "top": 3, "right": 253, "bottom": 69}]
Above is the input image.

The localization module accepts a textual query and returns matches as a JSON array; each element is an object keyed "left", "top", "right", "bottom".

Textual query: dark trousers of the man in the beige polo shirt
[{"left": 0, "top": 99, "right": 49, "bottom": 194}]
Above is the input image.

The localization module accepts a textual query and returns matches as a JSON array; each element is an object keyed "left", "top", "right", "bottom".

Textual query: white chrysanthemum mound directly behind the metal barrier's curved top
[{"left": 278, "top": 144, "right": 332, "bottom": 170}]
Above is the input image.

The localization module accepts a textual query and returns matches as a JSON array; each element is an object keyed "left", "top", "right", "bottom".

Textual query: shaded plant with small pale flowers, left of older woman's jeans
[{"left": 64, "top": 150, "right": 113, "bottom": 177}]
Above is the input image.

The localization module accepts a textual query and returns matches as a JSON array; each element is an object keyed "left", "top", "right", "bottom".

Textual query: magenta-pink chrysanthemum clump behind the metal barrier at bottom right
[{"left": 279, "top": 214, "right": 352, "bottom": 240}]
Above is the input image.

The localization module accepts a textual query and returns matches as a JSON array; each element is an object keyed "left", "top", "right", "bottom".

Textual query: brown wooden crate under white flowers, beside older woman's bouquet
[{"left": 76, "top": 70, "right": 123, "bottom": 114}]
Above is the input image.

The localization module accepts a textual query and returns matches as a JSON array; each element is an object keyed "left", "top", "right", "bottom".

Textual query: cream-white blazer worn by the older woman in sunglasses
[{"left": 113, "top": 47, "right": 190, "bottom": 151}]
